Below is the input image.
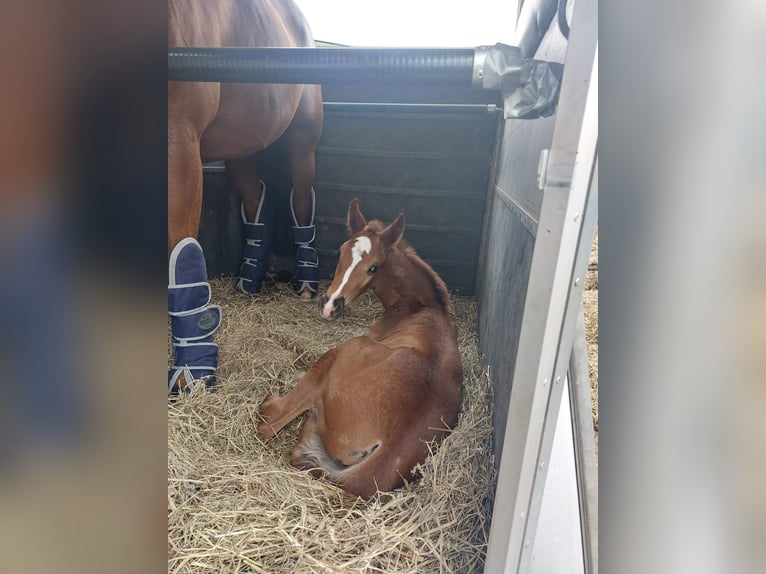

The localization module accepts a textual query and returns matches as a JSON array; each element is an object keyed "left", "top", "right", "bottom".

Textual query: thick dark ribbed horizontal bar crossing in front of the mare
[{"left": 168, "top": 47, "right": 475, "bottom": 87}]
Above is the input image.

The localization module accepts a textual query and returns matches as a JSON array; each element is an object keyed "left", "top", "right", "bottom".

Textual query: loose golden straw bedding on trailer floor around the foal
[{"left": 168, "top": 280, "right": 494, "bottom": 574}]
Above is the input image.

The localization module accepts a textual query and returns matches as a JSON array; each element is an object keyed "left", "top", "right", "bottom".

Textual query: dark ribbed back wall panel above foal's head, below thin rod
[{"left": 314, "top": 106, "right": 497, "bottom": 294}]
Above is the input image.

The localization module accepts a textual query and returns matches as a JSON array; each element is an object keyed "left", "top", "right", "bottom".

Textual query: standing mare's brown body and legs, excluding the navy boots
[{"left": 168, "top": 0, "right": 322, "bottom": 298}]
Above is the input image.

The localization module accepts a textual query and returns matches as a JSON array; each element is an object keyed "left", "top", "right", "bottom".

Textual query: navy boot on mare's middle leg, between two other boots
[{"left": 237, "top": 182, "right": 274, "bottom": 295}]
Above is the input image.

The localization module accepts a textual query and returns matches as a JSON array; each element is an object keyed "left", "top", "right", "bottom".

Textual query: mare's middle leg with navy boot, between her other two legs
[{"left": 226, "top": 156, "right": 275, "bottom": 295}]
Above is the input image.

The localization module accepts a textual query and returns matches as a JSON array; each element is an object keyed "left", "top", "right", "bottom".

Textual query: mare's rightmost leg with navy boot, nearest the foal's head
[{"left": 285, "top": 85, "right": 323, "bottom": 299}]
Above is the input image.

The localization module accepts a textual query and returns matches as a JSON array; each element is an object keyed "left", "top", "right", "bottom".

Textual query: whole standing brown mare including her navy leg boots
[{"left": 168, "top": 0, "right": 323, "bottom": 393}]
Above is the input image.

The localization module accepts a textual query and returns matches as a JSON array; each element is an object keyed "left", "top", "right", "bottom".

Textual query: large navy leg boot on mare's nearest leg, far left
[{"left": 168, "top": 237, "right": 221, "bottom": 394}]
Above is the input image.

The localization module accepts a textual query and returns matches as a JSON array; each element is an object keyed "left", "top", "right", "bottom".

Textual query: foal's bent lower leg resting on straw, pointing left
[{"left": 257, "top": 349, "right": 337, "bottom": 438}]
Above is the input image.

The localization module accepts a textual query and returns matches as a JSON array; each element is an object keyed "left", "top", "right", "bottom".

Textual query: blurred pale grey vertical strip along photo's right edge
[{"left": 599, "top": 1, "right": 766, "bottom": 574}]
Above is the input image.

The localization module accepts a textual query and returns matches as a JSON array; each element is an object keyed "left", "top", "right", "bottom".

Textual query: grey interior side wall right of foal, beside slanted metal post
[{"left": 478, "top": 4, "right": 567, "bottom": 469}]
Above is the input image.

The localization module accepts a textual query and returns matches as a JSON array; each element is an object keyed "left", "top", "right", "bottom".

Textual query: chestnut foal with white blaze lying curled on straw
[{"left": 258, "top": 200, "right": 463, "bottom": 498}]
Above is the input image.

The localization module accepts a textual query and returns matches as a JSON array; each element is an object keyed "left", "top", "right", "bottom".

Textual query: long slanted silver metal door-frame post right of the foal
[{"left": 486, "top": 0, "right": 598, "bottom": 574}]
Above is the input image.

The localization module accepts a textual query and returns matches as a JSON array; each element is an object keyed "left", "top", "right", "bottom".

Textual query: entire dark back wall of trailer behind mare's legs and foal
[{"left": 200, "top": 86, "right": 499, "bottom": 302}]
